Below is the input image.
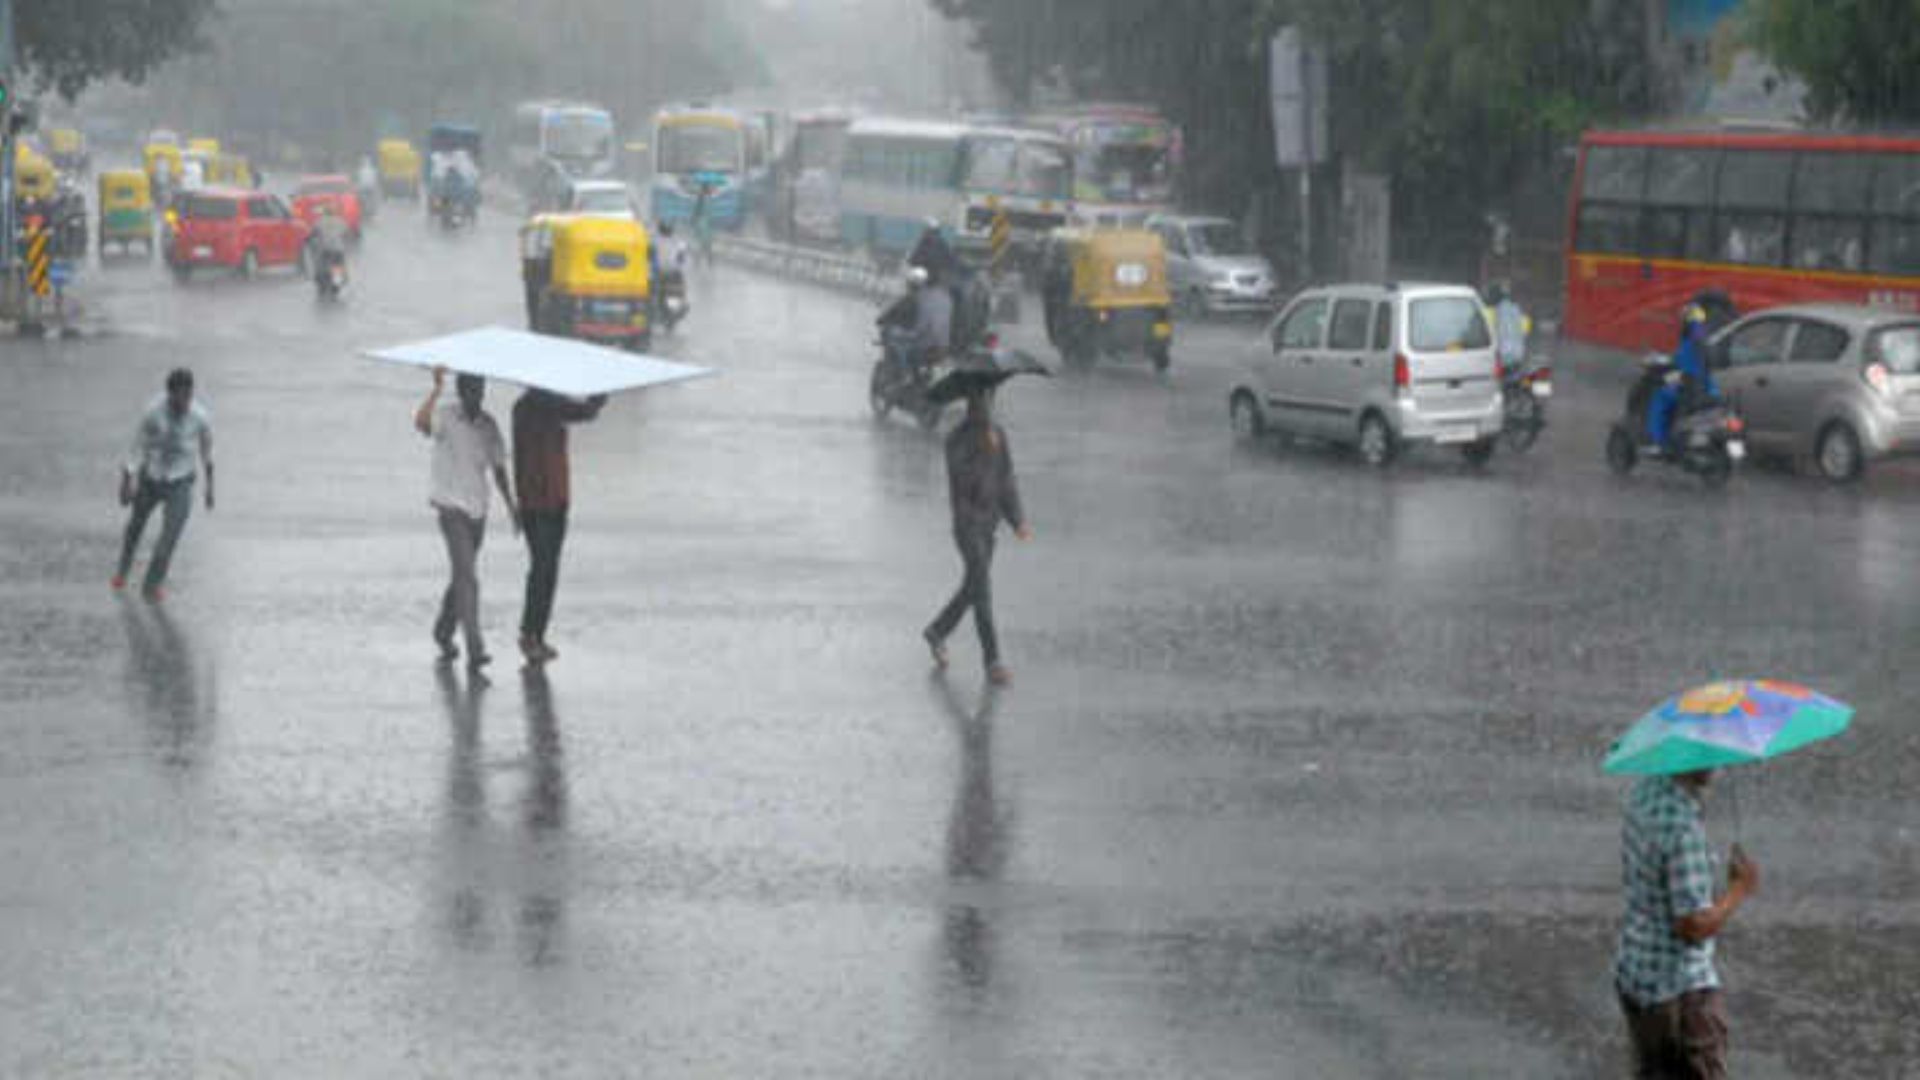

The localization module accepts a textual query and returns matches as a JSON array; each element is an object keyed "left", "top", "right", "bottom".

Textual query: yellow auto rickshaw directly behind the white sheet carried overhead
[{"left": 520, "top": 213, "right": 653, "bottom": 352}]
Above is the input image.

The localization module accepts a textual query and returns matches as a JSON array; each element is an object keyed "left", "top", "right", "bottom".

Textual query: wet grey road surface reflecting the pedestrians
[{"left": 0, "top": 195, "right": 1920, "bottom": 1078}]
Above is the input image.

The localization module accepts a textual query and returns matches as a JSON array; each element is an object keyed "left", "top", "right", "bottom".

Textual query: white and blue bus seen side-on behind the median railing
[{"left": 841, "top": 119, "right": 1073, "bottom": 258}]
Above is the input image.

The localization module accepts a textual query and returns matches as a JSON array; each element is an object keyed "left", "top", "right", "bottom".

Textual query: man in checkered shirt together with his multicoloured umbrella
[{"left": 1603, "top": 678, "right": 1853, "bottom": 1080}]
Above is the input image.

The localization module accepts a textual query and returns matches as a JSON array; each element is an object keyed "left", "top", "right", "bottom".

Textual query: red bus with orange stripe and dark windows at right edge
[{"left": 1565, "top": 133, "right": 1920, "bottom": 350}]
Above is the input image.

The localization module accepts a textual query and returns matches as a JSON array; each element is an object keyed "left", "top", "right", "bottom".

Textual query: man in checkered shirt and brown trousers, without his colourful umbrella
[{"left": 1613, "top": 769, "right": 1761, "bottom": 1080}]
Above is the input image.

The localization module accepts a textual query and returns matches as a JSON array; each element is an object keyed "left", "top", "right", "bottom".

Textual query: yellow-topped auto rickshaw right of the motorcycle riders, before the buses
[{"left": 1041, "top": 229, "right": 1173, "bottom": 371}]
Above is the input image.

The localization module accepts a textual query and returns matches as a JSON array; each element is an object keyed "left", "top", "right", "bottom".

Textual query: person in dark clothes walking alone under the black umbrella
[{"left": 922, "top": 390, "right": 1033, "bottom": 686}]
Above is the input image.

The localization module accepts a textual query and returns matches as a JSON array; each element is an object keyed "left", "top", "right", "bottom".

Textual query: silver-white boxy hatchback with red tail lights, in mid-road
[{"left": 1229, "top": 284, "right": 1503, "bottom": 465}]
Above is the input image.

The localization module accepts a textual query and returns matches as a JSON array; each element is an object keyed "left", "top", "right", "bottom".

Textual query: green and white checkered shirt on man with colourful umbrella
[{"left": 1613, "top": 776, "right": 1720, "bottom": 1005}]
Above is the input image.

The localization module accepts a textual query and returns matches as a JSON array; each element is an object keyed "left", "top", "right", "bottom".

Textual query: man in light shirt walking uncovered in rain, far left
[{"left": 113, "top": 367, "right": 213, "bottom": 601}]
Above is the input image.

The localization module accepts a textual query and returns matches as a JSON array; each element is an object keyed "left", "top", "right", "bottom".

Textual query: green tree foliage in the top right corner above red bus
[{"left": 1749, "top": 0, "right": 1920, "bottom": 123}]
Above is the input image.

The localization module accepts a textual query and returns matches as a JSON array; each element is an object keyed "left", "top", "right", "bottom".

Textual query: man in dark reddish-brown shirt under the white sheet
[{"left": 513, "top": 388, "right": 607, "bottom": 667}]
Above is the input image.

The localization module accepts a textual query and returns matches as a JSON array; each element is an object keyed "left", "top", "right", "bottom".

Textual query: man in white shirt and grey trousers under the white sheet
[{"left": 413, "top": 369, "right": 520, "bottom": 671}]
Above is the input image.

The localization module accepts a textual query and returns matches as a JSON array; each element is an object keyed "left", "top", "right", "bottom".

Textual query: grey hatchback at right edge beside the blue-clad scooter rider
[{"left": 1709, "top": 304, "right": 1920, "bottom": 484}]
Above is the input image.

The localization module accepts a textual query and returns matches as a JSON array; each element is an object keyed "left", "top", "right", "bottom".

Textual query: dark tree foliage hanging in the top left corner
[{"left": 13, "top": 0, "right": 213, "bottom": 100}]
